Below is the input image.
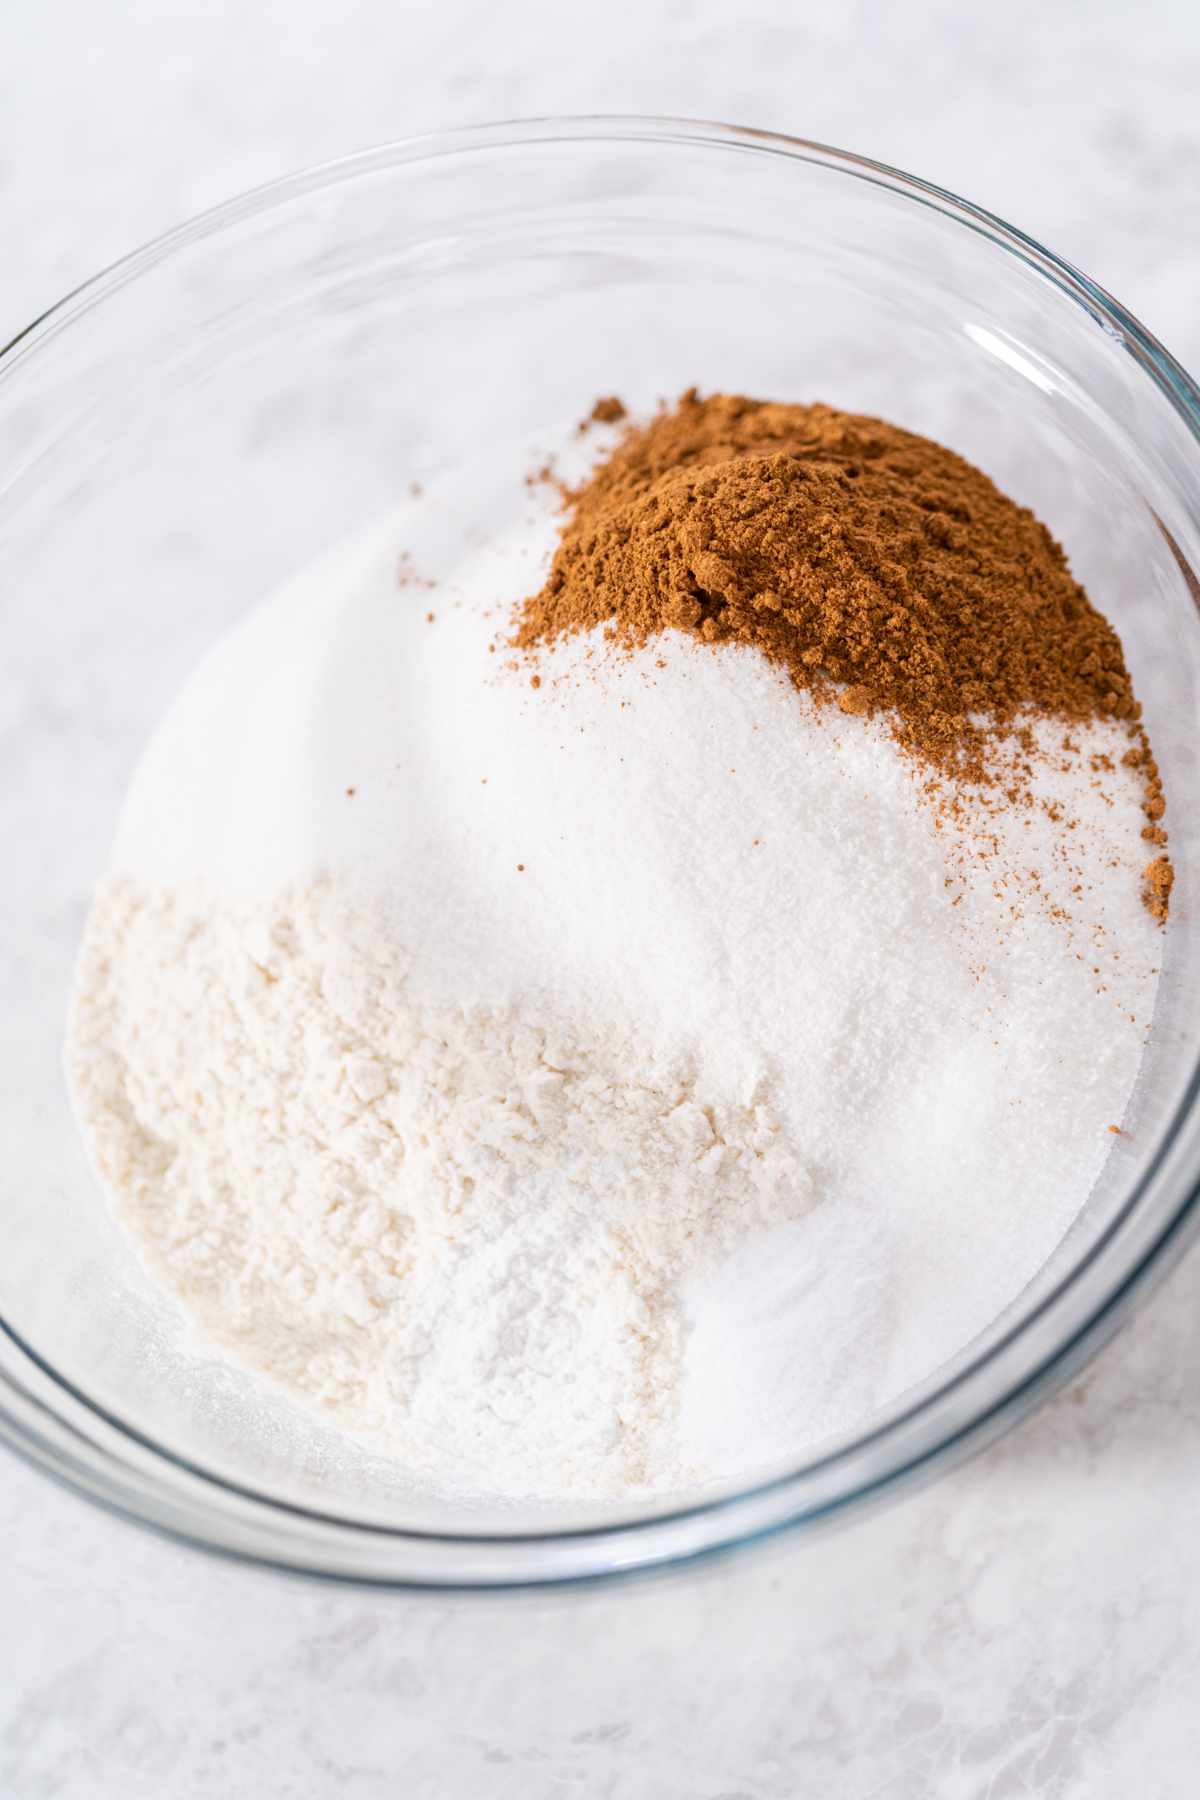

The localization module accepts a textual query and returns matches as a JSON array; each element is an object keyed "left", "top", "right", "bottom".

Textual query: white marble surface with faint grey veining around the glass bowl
[{"left": 0, "top": 0, "right": 1200, "bottom": 1800}]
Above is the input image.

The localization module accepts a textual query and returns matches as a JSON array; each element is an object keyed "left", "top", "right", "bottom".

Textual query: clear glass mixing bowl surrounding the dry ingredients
[{"left": 0, "top": 119, "right": 1200, "bottom": 1586}]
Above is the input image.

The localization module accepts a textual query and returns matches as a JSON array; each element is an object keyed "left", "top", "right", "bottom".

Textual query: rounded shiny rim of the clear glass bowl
[{"left": 0, "top": 113, "right": 1200, "bottom": 1589}]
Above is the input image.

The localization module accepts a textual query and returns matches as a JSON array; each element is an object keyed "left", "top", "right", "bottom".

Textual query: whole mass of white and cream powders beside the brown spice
[{"left": 68, "top": 457, "right": 1160, "bottom": 1496}]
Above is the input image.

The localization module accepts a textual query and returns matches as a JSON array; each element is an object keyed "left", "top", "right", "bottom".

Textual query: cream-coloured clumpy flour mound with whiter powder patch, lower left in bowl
[{"left": 68, "top": 878, "right": 813, "bottom": 1496}]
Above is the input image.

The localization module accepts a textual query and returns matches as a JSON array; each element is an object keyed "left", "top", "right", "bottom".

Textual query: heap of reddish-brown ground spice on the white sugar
[{"left": 515, "top": 389, "right": 1169, "bottom": 918}]
